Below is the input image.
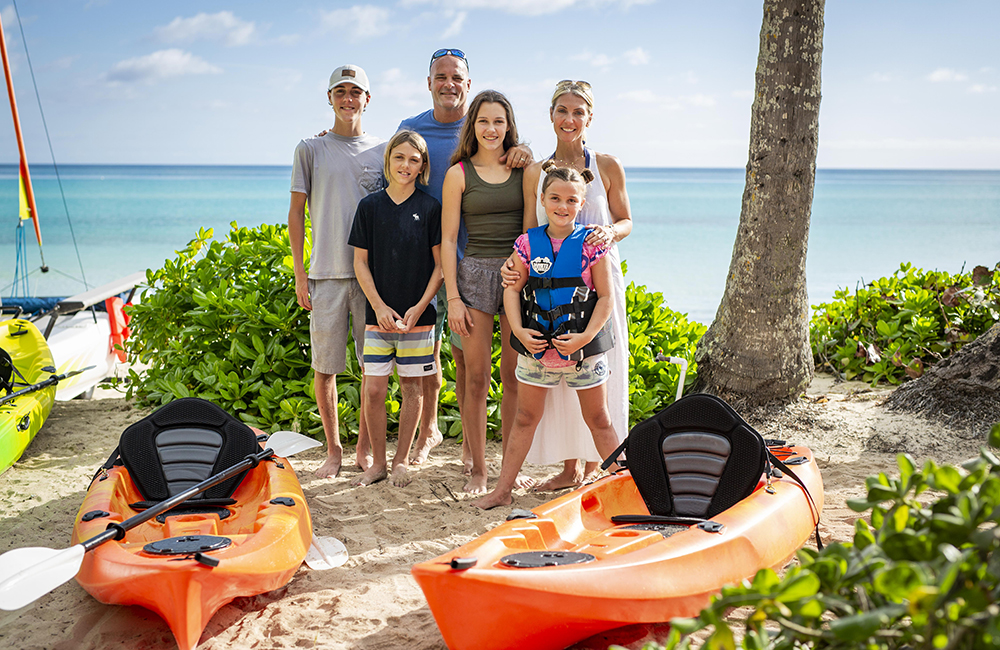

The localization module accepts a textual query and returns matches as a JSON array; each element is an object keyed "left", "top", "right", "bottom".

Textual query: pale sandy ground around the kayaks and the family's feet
[{"left": 0, "top": 376, "right": 988, "bottom": 650}]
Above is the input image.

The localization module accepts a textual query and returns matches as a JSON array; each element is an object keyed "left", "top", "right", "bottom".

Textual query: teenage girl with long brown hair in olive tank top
[{"left": 441, "top": 90, "right": 525, "bottom": 493}]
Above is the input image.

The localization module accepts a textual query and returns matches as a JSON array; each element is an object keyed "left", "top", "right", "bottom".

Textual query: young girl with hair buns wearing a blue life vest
[{"left": 473, "top": 164, "right": 618, "bottom": 509}]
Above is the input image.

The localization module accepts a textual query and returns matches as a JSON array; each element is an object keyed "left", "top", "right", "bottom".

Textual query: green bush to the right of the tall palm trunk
[{"left": 809, "top": 264, "right": 1000, "bottom": 385}]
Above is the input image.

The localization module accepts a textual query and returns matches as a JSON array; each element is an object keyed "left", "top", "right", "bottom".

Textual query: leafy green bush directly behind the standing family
[{"left": 126, "top": 223, "right": 705, "bottom": 440}]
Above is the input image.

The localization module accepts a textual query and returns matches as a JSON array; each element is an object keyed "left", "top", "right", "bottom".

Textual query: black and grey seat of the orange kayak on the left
[{"left": 118, "top": 397, "right": 260, "bottom": 509}]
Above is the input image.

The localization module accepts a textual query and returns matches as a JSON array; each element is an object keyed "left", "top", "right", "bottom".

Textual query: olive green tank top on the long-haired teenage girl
[{"left": 462, "top": 159, "right": 524, "bottom": 258}]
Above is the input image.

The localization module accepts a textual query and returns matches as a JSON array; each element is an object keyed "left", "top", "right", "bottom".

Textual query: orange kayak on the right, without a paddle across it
[{"left": 412, "top": 398, "right": 823, "bottom": 650}]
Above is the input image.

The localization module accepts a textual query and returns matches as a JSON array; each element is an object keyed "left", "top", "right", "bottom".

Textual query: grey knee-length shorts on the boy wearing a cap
[{"left": 309, "top": 278, "right": 368, "bottom": 375}]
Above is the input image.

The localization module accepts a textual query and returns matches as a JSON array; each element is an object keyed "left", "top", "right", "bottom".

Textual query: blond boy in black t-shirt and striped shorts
[{"left": 347, "top": 131, "right": 442, "bottom": 487}]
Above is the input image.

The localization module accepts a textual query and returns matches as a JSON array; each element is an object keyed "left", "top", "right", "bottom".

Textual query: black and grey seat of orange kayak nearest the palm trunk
[{"left": 626, "top": 393, "right": 767, "bottom": 519}]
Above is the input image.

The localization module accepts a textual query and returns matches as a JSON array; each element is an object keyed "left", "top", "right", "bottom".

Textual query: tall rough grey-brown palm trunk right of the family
[{"left": 695, "top": 0, "right": 824, "bottom": 404}]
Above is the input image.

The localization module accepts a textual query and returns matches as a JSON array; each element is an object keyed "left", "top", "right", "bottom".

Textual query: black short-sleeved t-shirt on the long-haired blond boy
[{"left": 347, "top": 189, "right": 441, "bottom": 325}]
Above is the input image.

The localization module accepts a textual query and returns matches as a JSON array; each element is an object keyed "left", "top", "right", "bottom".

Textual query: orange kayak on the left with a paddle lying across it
[{"left": 73, "top": 400, "right": 312, "bottom": 650}]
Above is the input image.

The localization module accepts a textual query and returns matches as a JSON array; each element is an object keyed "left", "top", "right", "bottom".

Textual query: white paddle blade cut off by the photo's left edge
[{"left": 0, "top": 544, "right": 86, "bottom": 611}]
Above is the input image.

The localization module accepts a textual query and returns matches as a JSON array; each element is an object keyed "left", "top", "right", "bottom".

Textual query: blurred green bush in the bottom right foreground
[{"left": 646, "top": 424, "right": 1000, "bottom": 650}]
